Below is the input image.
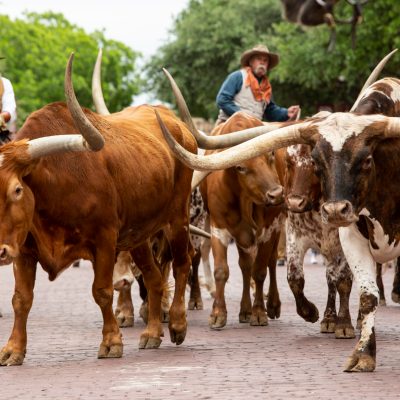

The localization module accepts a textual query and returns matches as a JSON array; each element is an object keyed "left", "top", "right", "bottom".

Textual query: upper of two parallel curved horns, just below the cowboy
[{"left": 163, "top": 68, "right": 285, "bottom": 150}]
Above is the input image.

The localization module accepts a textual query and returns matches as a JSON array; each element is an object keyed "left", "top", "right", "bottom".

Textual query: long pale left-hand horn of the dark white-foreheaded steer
[{"left": 154, "top": 110, "right": 310, "bottom": 171}]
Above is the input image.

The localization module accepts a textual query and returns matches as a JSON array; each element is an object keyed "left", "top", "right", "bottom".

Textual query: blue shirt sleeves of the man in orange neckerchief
[{"left": 216, "top": 70, "right": 288, "bottom": 122}]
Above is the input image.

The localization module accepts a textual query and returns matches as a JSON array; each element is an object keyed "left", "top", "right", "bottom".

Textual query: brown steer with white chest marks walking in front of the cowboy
[{"left": 200, "top": 112, "right": 284, "bottom": 329}]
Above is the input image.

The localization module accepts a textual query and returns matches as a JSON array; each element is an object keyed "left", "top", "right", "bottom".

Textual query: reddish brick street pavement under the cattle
[{"left": 0, "top": 247, "right": 400, "bottom": 400}]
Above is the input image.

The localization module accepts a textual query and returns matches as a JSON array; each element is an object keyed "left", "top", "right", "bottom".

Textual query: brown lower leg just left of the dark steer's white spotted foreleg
[{"left": 335, "top": 260, "right": 355, "bottom": 339}]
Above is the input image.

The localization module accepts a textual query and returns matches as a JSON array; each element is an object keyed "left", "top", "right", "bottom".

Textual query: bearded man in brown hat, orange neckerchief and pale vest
[{"left": 217, "top": 45, "right": 300, "bottom": 124}]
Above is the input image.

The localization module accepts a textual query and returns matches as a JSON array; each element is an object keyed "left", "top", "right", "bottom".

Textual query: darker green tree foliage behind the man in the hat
[{"left": 146, "top": 0, "right": 400, "bottom": 118}]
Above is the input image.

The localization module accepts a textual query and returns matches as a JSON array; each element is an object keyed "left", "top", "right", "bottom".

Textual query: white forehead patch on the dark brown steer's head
[{"left": 315, "top": 113, "right": 387, "bottom": 151}]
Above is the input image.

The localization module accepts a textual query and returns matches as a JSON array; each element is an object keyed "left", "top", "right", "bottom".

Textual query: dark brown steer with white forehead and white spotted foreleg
[{"left": 159, "top": 69, "right": 400, "bottom": 372}]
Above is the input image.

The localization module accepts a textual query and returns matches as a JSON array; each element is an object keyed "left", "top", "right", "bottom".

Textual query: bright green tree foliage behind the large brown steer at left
[{"left": 0, "top": 13, "right": 140, "bottom": 125}]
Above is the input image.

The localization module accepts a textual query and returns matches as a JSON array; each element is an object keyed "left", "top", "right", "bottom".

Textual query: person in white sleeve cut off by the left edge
[{"left": 0, "top": 57, "right": 17, "bottom": 143}]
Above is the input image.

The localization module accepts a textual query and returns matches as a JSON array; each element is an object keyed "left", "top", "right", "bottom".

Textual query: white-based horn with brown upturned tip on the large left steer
[{"left": 28, "top": 53, "right": 104, "bottom": 159}]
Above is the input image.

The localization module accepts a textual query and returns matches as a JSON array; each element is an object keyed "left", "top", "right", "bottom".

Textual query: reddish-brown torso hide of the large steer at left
[{"left": 8, "top": 103, "right": 196, "bottom": 279}]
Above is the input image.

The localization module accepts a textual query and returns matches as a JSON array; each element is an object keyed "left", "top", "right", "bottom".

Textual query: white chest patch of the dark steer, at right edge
[{"left": 360, "top": 208, "right": 400, "bottom": 264}]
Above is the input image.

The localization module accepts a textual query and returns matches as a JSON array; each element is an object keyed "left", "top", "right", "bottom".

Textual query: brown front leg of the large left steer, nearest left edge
[{"left": 0, "top": 257, "right": 37, "bottom": 366}]
